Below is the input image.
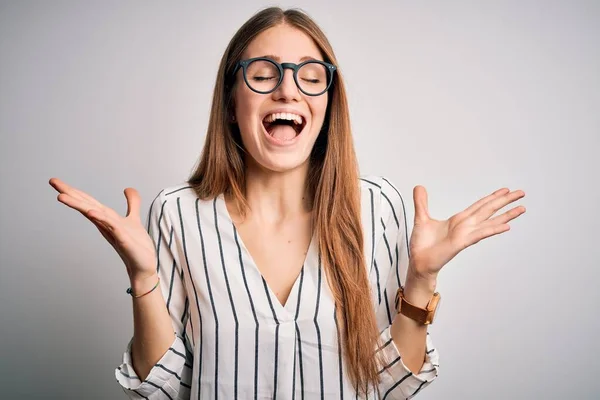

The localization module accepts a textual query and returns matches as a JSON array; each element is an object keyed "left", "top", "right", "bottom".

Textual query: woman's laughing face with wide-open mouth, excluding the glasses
[{"left": 234, "top": 24, "right": 328, "bottom": 172}]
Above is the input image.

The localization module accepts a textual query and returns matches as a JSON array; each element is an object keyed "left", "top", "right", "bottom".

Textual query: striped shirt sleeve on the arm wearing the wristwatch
[{"left": 373, "top": 177, "right": 439, "bottom": 400}]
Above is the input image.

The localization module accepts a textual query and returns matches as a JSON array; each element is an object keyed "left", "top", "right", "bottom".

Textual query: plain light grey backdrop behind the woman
[{"left": 0, "top": 0, "right": 600, "bottom": 400}]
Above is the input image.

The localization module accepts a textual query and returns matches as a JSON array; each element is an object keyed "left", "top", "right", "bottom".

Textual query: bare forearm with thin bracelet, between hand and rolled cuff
[{"left": 131, "top": 275, "right": 175, "bottom": 381}]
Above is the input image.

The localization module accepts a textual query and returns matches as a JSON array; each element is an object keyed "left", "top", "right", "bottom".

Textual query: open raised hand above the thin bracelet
[{"left": 49, "top": 178, "right": 156, "bottom": 284}]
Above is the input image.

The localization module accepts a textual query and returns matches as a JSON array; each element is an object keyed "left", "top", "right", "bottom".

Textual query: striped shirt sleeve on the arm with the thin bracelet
[{"left": 115, "top": 190, "right": 193, "bottom": 400}]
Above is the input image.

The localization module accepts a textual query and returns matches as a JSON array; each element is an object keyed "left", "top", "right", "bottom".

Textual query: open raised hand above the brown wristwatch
[{"left": 409, "top": 186, "right": 525, "bottom": 281}]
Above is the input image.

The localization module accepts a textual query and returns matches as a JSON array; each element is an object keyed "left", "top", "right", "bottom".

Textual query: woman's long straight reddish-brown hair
[{"left": 188, "top": 7, "right": 381, "bottom": 394}]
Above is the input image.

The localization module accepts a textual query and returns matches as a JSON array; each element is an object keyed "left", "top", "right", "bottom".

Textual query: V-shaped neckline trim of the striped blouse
[{"left": 217, "top": 193, "right": 316, "bottom": 319}]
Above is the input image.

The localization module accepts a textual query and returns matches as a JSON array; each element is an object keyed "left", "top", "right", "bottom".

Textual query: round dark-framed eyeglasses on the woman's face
[{"left": 233, "top": 57, "right": 337, "bottom": 96}]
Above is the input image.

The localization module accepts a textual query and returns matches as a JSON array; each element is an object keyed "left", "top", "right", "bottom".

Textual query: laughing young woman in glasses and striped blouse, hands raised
[{"left": 50, "top": 8, "right": 525, "bottom": 399}]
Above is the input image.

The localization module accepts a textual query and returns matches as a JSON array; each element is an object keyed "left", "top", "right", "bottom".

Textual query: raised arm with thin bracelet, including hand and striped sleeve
[{"left": 49, "top": 178, "right": 193, "bottom": 399}]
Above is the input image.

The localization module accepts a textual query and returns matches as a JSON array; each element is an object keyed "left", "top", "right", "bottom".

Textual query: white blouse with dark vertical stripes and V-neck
[{"left": 115, "top": 176, "right": 439, "bottom": 400}]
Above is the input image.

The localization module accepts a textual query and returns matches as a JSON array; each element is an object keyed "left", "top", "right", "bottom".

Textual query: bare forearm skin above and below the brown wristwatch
[{"left": 391, "top": 267, "right": 436, "bottom": 374}]
